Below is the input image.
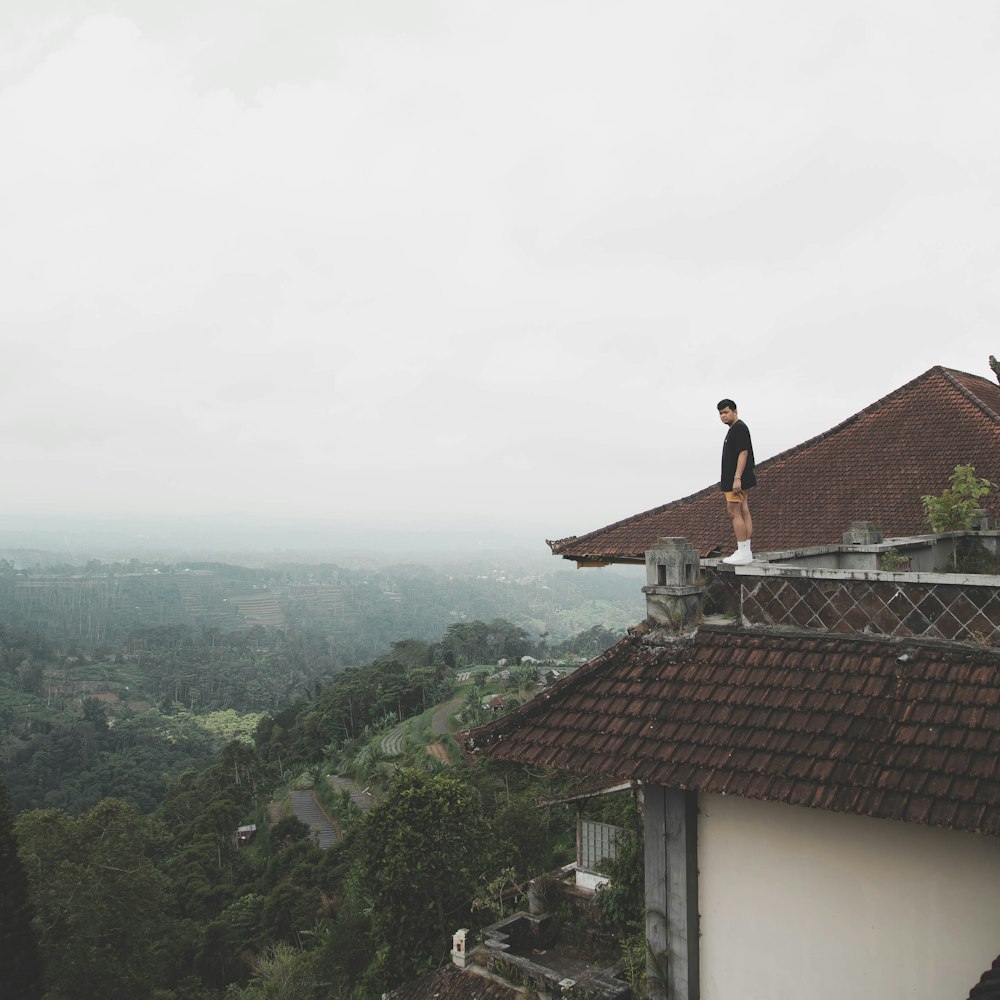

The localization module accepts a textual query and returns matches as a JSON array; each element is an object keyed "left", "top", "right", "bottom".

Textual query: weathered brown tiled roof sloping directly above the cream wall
[{"left": 466, "top": 626, "right": 1000, "bottom": 835}]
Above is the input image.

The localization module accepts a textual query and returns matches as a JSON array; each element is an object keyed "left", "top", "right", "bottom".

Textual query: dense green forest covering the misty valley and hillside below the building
[{"left": 0, "top": 565, "right": 641, "bottom": 1000}]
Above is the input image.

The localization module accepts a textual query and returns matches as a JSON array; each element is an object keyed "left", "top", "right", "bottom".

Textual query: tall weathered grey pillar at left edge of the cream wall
[{"left": 642, "top": 785, "right": 701, "bottom": 1000}]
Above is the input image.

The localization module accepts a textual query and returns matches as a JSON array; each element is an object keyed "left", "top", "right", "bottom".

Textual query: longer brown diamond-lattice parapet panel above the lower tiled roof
[{"left": 742, "top": 577, "right": 1000, "bottom": 643}]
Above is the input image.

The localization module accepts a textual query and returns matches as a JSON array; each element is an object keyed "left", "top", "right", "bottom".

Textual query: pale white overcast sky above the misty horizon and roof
[{"left": 0, "top": 0, "right": 1000, "bottom": 539}]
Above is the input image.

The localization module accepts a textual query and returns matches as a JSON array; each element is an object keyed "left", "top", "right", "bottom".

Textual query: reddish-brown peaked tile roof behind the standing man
[{"left": 549, "top": 367, "right": 1000, "bottom": 562}]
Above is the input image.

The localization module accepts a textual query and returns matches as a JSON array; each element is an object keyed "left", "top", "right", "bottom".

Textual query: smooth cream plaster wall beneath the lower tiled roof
[{"left": 698, "top": 795, "right": 1000, "bottom": 1000}]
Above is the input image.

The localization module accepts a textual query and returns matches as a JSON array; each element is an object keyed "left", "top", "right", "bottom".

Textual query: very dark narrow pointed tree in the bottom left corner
[{"left": 0, "top": 778, "right": 42, "bottom": 1000}]
